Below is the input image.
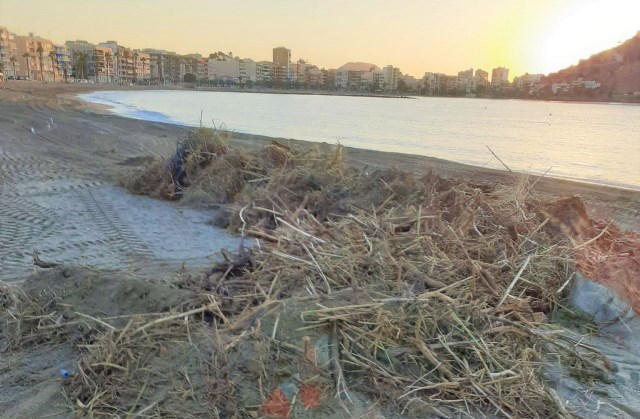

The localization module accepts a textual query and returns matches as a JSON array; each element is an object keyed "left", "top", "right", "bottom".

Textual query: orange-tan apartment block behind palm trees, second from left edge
[{"left": 14, "top": 33, "right": 55, "bottom": 81}]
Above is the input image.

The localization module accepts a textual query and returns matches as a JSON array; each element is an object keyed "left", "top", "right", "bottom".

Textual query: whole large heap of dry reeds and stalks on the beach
[{"left": 3, "top": 129, "right": 624, "bottom": 417}]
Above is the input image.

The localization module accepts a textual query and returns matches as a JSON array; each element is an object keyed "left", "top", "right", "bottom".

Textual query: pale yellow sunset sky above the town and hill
[{"left": 0, "top": 0, "right": 640, "bottom": 79}]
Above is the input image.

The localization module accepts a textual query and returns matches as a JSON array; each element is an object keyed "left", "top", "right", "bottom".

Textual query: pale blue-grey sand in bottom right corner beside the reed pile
[{"left": 549, "top": 275, "right": 640, "bottom": 418}]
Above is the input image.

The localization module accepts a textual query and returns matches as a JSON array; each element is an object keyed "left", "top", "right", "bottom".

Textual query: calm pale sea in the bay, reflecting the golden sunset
[{"left": 80, "top": 90, "right": 640, "bottom": 190}]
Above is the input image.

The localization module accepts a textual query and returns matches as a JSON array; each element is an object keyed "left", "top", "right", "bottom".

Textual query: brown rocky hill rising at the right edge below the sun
[{"left": 545, "top": 32, "right": 640, "bottom": 96}]
